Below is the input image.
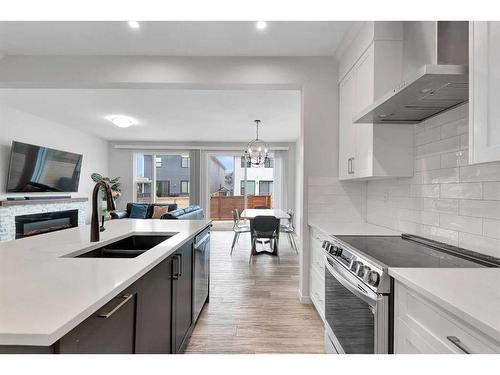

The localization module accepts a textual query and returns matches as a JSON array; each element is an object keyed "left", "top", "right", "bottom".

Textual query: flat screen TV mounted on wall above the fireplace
[{"left": 7, "top": 141, "right": 83, "bottom": 193}]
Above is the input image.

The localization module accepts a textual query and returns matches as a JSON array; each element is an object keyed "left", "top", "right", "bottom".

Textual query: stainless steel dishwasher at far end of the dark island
[{"left": 193, "top": 228, "right": 210, "bottom": 322}]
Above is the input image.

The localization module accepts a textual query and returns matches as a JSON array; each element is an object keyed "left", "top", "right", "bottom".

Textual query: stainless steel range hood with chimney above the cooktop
[{"left": 353, "top": 22, "right": 469, "bottom": 124}]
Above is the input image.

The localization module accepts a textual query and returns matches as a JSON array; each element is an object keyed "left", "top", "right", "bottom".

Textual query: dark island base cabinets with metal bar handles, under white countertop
[{"left": 0, "top": 228, "right": 210, "bottom": 354}]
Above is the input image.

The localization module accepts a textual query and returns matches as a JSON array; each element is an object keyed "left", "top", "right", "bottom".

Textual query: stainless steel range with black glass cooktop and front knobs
[{"left": 323, "top": 234, "right": 500, "bottom": 354}]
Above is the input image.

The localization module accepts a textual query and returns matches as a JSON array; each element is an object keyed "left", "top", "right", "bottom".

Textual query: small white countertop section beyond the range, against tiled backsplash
[{"left": 309, "top": 219, "right": 401, "bottom": 236}]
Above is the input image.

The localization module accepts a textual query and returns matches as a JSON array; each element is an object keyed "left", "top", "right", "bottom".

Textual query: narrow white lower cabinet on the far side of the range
[{"left": 309, "top": 228, "right": 328, "bottom": 321}]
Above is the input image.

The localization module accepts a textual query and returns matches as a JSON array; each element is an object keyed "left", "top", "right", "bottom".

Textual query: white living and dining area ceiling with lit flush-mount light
[{"left": 0, "top": 89, "right": 301, "bottom": 142}]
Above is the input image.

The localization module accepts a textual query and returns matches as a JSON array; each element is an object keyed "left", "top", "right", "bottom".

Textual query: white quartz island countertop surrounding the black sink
[{"left": 0, "top": 219, "right": 210, "bottom": 346}]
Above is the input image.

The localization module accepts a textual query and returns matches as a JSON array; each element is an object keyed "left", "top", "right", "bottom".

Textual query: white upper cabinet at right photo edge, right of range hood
[{"left": 469, "top": 21, "right": 500, "bottom": 164}]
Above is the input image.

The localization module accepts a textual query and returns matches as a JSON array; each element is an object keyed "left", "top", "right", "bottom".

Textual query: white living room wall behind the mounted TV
[{"left": 0, "top": 103, "right": 108, "bottom": 221}]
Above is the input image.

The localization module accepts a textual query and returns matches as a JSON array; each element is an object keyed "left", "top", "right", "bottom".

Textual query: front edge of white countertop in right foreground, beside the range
[{"left": 389, "top": 268, "right": 500, "bottom": 343}]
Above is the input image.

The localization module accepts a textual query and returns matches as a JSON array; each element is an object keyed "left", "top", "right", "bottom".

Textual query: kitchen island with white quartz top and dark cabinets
[{"left": 0, "top": 219, "right": 210, "bottom": 353}]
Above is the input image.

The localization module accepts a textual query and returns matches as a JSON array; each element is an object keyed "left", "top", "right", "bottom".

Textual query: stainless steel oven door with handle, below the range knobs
[{"left": 325, "top": 255, "right": 389, "bottom": 354}]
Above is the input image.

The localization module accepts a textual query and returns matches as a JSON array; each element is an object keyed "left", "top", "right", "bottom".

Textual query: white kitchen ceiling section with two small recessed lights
[{"left": 0, "top": 21, "right": 352, "bottom": 56}]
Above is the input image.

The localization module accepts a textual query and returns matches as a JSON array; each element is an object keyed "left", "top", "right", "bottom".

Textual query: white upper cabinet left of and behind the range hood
[{"left": 339, "top": 22, "right": 413, "bottom": 180}]
